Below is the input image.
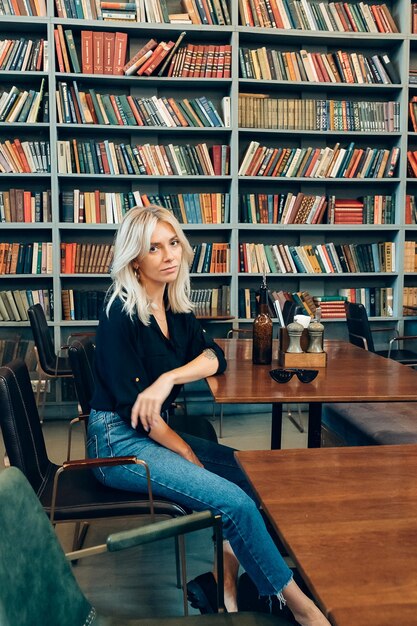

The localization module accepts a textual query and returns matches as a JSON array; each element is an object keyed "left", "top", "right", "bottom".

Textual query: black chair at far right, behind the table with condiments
[{"left": 345, "top": 302, "right": 417, "bottom": 367}]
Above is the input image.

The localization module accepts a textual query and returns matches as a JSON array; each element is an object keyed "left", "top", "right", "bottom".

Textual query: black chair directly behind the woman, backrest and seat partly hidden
[{"left": 68, "top": 336, "right": 217, "bottom": 442}]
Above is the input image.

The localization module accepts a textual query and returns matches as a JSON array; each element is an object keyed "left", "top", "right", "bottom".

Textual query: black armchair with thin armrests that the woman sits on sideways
[{"left": 0, "top": 360, "right": 190, "bottom": 608}]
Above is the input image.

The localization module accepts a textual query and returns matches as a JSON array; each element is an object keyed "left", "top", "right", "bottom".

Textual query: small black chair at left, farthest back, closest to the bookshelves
[{"left": 28, "top": 304, "right": 72, "bottom": 421}]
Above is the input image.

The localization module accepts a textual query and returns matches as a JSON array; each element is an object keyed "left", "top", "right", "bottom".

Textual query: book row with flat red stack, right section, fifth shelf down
[{"left": 240, "top": 192, "right": 395, "bottom": 224}]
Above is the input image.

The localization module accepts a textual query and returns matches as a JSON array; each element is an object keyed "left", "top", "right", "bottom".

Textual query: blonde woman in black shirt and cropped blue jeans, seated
[{"left": 88, "top": 206, "right": 329, "bottom": 626}]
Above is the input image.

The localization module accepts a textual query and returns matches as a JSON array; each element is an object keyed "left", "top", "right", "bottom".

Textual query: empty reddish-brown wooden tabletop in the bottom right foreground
[{"left": 235, "top": 445, "right": 417, "bottom": 626}]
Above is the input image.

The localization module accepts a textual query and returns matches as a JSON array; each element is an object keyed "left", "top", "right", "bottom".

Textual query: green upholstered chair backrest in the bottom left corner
[{"left": 0, "top": 467, "right": 94, "bottom": 626}]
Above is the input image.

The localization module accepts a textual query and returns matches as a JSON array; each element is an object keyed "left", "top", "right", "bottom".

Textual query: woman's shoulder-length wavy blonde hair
[{"left": 106, "top": 205, "right": 193, "bottom": 326}]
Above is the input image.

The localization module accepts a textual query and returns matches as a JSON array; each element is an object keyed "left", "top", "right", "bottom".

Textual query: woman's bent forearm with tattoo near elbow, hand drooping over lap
[{"left": 131, "top": 348, "right": 219, "bottom": 432}]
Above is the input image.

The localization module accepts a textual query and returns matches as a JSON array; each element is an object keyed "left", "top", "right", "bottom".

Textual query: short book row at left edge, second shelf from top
[{"left": 0, "top": 37, "right": 49, "bottom": 72}]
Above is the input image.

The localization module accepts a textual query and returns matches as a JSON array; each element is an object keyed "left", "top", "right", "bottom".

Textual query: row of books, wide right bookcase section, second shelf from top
[{"left": 239, "top": 46, "right": 401, "bottom": 85}]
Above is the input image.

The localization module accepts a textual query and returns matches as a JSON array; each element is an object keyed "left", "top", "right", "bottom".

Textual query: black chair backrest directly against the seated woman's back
[{"left": 68, "top": 336, "right": 95, "bottom": 414}]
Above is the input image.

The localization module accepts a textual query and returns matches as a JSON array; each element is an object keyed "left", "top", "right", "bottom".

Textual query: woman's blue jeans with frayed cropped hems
[{"left": 87, "top": 410, "right": 292, "bottom": 595}]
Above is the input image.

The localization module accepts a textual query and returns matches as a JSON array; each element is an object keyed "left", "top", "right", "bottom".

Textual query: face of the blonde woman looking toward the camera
[{"left": 137, "top": 222, "right": 182, "bottom": 292}]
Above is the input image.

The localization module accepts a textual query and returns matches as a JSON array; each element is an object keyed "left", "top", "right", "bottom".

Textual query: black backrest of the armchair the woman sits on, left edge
[{"left": 0, "top": 359, "right": 51, "bottom": 493}]
